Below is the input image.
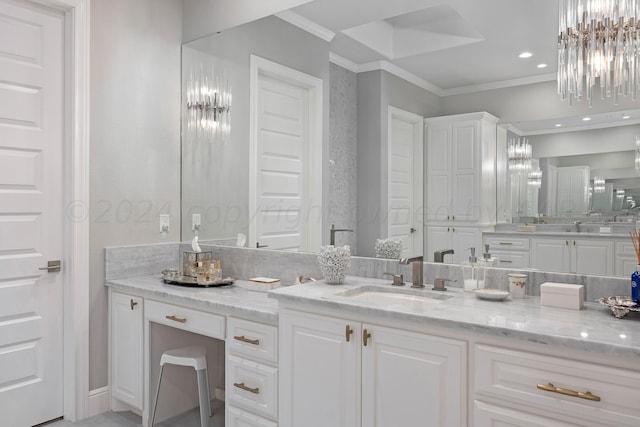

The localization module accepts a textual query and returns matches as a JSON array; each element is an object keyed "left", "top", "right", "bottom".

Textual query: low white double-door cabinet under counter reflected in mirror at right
[{"left": 531, "top": 238, "right": 614, "bottom": 275}]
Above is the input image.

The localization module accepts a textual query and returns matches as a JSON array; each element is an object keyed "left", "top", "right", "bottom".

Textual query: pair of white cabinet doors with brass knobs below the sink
[{"left": 280, "top": 309, "right": 466, "bottom": 427}]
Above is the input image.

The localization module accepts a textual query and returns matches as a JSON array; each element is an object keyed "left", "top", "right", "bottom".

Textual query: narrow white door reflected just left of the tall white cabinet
[{"left": 387, "top": 107, "right": 424, "bottom": 256}]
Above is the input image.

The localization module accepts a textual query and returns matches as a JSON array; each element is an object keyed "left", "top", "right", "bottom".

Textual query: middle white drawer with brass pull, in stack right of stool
[{"left": 225, "top": 354, "right": 278, "bottom": 418}]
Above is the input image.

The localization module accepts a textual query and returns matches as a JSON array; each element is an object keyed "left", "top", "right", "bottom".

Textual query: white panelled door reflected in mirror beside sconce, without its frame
[{"left": 254, "top": 74, "right": 309, "bottom": 250}]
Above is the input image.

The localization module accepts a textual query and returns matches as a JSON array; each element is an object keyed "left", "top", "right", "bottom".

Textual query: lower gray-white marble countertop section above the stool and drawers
[{"left": 105, "top": 275, "right": 278, "bottom": 325}]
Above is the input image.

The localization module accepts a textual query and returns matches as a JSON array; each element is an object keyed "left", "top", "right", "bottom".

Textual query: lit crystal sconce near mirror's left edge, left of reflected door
[{"left": 186, "top": 65, "right": 231, "bottom": 143}]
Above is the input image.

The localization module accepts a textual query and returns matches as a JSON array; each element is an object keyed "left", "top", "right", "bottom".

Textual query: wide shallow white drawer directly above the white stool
[{"left": 145, "top": 300, "right": 225, "bottom": 339}]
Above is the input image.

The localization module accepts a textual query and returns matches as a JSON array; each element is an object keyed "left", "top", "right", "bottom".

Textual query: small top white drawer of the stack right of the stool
[{"left": 227, "top": 317, "right": 278, "bottom": 363}]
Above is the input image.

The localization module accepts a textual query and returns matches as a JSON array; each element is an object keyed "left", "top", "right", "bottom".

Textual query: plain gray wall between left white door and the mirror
[{"left": 89, "top": 0, "right": 182, "bottom": 390}]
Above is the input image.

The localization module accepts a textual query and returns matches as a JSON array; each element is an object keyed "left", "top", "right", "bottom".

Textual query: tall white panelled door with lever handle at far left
[{"left": 0, "top": 0, "right": 64, "bottom": 427}]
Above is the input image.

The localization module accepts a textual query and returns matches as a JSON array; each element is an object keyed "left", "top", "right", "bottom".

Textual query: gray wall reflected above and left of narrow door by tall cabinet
[{"left": 357, "top": 70, "right": 441, "bottom": 256}]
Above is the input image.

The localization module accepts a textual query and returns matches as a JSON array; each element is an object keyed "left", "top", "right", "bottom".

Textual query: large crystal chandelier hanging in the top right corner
[{"left": 558, "top": 0, "right": 640, "bottom": 106}]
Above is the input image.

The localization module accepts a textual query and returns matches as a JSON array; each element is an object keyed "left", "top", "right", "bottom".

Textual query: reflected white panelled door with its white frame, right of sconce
[{"left": 249, "top": 57, "right": 322, "bottom": 251}]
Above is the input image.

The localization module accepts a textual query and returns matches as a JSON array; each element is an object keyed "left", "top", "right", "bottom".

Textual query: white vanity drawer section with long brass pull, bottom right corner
[{"left": 472, "top": 344, "right": 640, "bottom": 427}]
